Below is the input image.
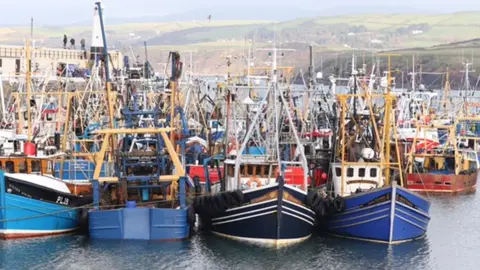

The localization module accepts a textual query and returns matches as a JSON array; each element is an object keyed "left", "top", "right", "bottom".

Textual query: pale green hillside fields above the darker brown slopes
[{"left": 0, "top": 12, "right": 480, "bottom": 49}]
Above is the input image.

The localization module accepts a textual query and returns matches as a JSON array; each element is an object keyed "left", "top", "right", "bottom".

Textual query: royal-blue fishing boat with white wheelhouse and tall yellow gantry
[{"left": 321, "top": 62, "right": 430, "bottom": 244}]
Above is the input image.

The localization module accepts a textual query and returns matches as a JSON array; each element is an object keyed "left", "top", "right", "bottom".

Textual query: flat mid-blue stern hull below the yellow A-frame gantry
[{"left": 88, "top": 208, "right": 190, "bottom": 241}]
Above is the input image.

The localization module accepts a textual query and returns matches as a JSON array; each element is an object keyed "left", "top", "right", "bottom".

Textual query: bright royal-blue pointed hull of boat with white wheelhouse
[{"left": 324, "top": 185, "right": 430, "bottom": 244}]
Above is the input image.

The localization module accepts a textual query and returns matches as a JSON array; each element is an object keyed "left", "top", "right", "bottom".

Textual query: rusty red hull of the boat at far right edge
[{"left": 407, "top": 171, "right": 478, "bottom": 193}]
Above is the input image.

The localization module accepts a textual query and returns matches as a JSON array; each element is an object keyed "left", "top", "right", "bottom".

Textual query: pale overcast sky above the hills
[{"left": 0, "top": 0, "right": 480, "bottom": 25}]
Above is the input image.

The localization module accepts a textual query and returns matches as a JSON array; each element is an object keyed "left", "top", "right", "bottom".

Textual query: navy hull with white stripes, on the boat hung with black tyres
[{"left": 207, "top": 184, "right": 315, "bottom": 247}]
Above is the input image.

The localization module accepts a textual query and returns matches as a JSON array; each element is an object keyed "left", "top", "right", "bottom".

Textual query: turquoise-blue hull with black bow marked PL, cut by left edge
[{"left": 0, "top": 171, "right": 92, "bottom": 239}]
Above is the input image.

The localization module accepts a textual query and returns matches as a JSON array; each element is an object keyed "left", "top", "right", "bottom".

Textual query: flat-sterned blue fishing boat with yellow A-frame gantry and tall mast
[{"left": 88, "top": 11, "right": 194, "bottom": 238}]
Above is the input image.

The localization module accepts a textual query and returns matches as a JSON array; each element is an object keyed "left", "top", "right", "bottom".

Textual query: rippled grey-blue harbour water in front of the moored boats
[{"left": 0, "top": 194, "right": 480, "bottom": 270}]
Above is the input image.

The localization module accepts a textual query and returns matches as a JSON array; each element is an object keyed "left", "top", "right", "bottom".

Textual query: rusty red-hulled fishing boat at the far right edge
[{"left": 406, "top": 125, "right": 480, "bottom": 193}]
